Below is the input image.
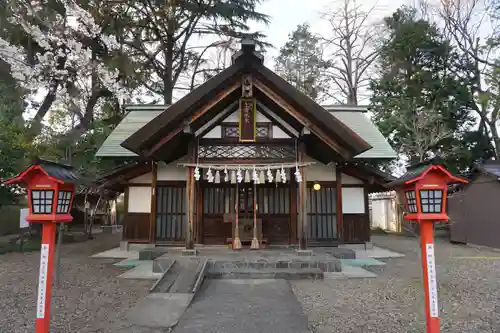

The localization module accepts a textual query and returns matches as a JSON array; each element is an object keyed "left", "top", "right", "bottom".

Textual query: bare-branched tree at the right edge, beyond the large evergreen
[{"left": 438, "top": 0, "right": 500, "bottom": 159}]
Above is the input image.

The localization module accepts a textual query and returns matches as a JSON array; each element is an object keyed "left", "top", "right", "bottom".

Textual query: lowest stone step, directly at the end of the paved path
[{"left": 205, "top": 267, "right": 324, "bottom": 280}]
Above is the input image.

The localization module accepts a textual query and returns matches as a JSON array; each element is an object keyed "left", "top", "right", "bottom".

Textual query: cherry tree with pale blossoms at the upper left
[{"left": 0, "top": 0, "right": 131, "bottom": 140}]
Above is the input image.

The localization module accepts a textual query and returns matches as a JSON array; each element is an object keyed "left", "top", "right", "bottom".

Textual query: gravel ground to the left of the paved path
[{"left": 0, "top": 234, "right": 163, "bottom": 333}]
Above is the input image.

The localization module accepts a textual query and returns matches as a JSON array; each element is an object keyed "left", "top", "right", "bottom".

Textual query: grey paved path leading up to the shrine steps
[{"left": 173, "top": 280, "right": 310, "bottom": 333}]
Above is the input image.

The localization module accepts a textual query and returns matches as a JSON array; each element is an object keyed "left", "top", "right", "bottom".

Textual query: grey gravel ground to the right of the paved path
[{"left": 292, "top": 236, "right": 500, "bottom": 333}]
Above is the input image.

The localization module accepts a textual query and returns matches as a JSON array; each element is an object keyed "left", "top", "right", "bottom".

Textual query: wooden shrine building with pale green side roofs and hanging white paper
[{"left": 96, "top": 41, "right": 397, "bottom": 248}]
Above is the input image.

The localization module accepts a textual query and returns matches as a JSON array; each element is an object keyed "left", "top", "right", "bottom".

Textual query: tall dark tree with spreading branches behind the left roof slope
[{"left": 119, "top": 0, "right": 269, "bottom": 104}]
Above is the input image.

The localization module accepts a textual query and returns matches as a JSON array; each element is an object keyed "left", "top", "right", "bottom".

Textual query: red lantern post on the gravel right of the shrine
[{"left": 386, "top": 158, "right": 467, "bottom": 333}]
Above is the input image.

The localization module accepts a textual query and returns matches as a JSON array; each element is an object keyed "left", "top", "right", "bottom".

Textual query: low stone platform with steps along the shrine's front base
[{"left": 92, "top": 244, "right": 402, "bottom": 279}]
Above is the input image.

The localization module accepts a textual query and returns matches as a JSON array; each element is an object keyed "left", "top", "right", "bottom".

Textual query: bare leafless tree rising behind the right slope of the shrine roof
[{"left": 322, "top": 0, "right": 379, "bottom": 104}]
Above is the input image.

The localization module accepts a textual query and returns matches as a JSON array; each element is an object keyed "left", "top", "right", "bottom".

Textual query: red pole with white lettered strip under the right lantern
[{"left": 420, "top": 220, "right": 440, "bottom": 333}]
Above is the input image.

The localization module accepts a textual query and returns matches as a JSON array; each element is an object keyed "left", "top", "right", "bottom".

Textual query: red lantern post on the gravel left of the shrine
[{"left": 4, "top": 160, "right": 79, "bottom": 333}]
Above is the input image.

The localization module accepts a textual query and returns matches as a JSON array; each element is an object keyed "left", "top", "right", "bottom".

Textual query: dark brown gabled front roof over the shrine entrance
[{"left": 122, "top": 43, "right": 371, "bottom": 157}]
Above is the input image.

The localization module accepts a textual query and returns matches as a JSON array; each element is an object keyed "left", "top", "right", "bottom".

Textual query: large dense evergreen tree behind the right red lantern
[{"left": 371, "top": 7, "right": 484, "bottom": 171}]
